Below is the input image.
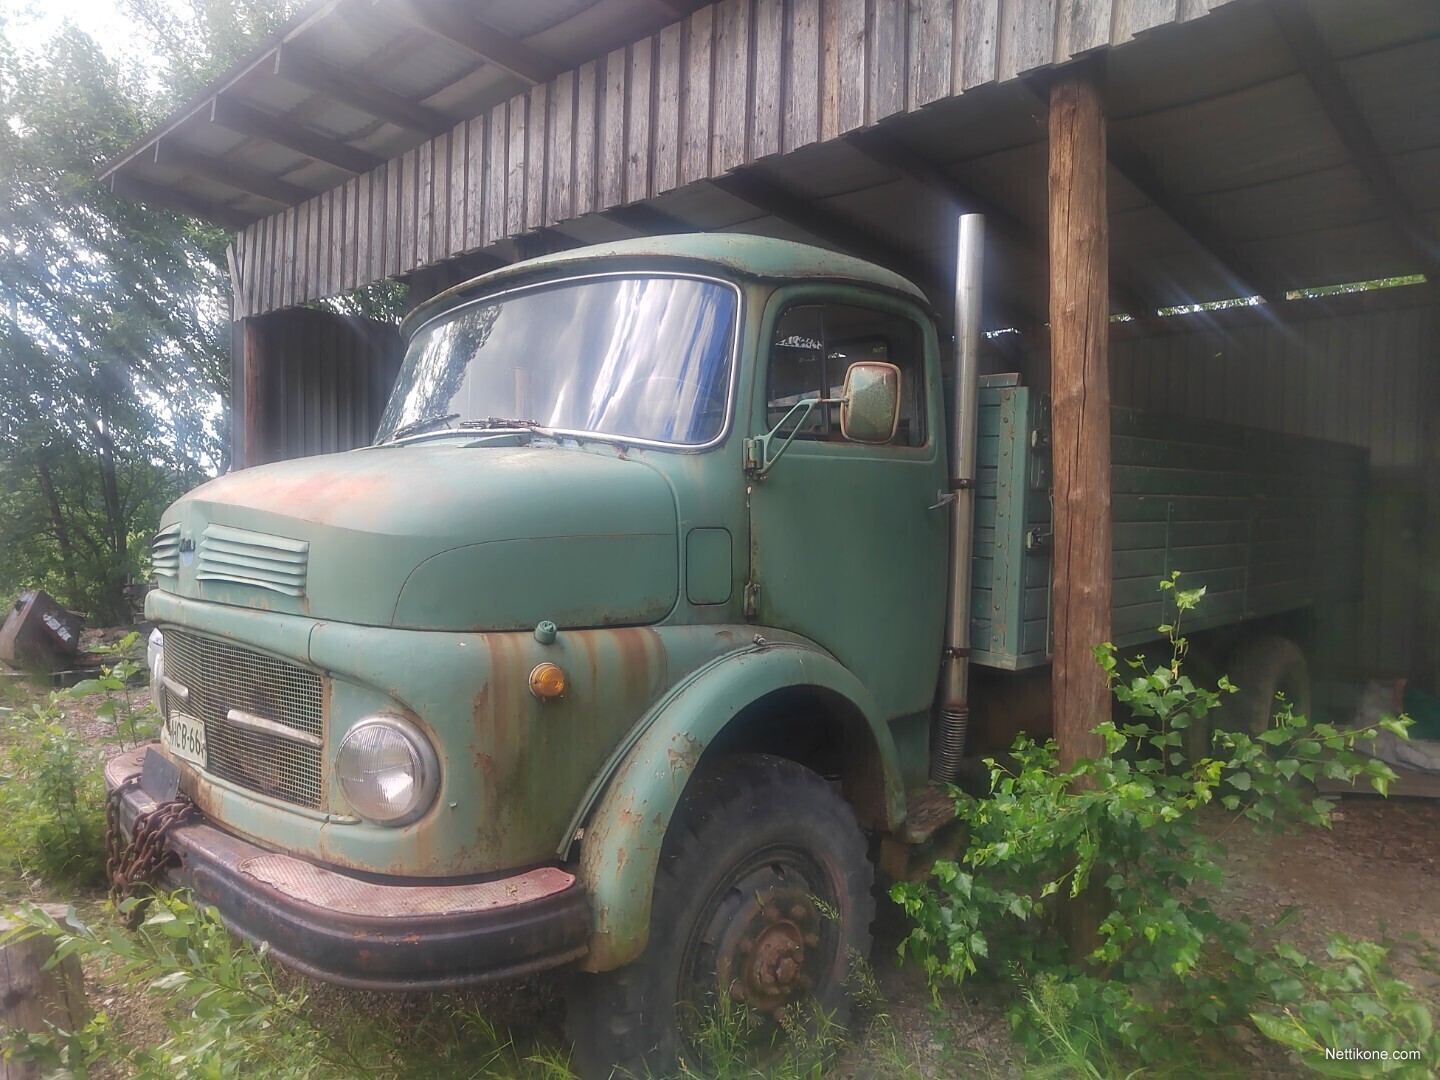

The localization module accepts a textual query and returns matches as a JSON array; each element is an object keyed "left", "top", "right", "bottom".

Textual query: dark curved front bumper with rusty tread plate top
[{"left": 105, "top": 746, "right": 589, "bottom": 991}]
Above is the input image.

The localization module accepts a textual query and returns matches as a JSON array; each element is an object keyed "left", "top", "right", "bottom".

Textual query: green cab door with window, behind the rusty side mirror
[{"left": 747, "top": 287, "right": 949, "bottom": 719}]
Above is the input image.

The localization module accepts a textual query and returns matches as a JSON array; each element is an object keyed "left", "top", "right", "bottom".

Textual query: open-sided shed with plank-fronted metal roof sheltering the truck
[{"left": 104, "top": 0, "right": 1440, "bottom": 754}]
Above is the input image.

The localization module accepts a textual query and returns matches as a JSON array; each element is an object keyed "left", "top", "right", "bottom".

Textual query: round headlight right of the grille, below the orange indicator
[{"left": 336, "top": 716, "right": 441, "bottom": 825}]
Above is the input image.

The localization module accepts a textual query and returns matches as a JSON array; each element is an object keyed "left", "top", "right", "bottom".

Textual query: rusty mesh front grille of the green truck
[{"left": 161, "top": 626, "right": 325, "bottom": 808}]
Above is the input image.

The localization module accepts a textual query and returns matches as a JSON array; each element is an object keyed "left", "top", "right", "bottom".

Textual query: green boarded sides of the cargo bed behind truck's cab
[{"left": 971, "top": 376, "right": 1368, "bottom": 670}]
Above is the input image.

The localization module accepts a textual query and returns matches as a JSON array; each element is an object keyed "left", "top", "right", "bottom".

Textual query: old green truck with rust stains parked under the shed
[{"left": 107, "top": 219, "right": 1365, "bottom": 1076}]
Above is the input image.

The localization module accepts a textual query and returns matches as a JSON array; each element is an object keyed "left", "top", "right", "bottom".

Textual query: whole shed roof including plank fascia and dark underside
[{"left": 105, "top": 0, "right": 1440, "bottom": 321}]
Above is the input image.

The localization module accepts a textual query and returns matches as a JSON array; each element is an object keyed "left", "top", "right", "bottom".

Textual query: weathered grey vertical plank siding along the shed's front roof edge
[{"left": 235, "top": 0, "right": 1227, "bottom": 318}]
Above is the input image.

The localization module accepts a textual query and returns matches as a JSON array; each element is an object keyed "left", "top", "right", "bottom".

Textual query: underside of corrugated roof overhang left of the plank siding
[{"left": 101, "top": 0, "right": 697, "bottom": 229}]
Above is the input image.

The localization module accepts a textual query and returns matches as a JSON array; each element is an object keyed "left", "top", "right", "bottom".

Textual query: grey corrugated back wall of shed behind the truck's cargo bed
[{"left": 1110, "top": 294, "right": 1440, "bottom": 677}]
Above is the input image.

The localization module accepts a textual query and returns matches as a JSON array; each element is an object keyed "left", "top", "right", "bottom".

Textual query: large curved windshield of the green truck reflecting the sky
[{"left": 376, "top": 276, "right": 737, "bottom": 446}]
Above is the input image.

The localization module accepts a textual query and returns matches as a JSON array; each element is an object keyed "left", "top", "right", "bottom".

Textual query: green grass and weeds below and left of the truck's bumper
[{"left": 0, "top": 680, "right": 973, "bottom": 1080}]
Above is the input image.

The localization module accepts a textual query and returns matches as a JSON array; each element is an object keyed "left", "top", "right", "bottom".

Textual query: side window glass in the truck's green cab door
[{"left": 765, "top": 304, "right": 926, "bottom": 446}]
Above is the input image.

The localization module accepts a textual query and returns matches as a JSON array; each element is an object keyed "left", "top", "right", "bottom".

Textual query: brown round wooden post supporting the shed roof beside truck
[{"left": 1050, "top": 69, "right": 1112, "bottom": 766}]
